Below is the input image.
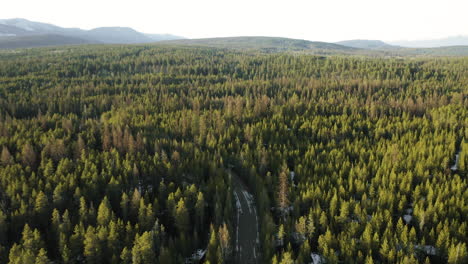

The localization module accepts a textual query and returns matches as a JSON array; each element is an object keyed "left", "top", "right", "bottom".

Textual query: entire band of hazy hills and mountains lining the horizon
[{"left": 0, "top": 18, "right": 468, "bottom": 56}]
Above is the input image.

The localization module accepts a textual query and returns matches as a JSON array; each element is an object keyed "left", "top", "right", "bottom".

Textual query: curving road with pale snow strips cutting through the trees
[{"left": 229, "top": 172, "right": 260, "bottom": 264}]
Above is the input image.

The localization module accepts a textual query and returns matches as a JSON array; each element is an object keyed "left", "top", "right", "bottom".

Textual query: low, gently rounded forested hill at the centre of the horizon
[{"left": 160, "top": 37, "right": 356, "bottom": 53}]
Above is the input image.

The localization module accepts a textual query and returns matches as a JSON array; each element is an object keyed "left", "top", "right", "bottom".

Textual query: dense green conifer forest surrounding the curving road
[{"left": 0, "top": 45, "right": 468, "bottom": 264}]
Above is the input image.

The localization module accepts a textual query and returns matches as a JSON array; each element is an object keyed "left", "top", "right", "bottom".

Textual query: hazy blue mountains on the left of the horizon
[{"left": 0, "top": 18, "right": 182, "bottom": 48}]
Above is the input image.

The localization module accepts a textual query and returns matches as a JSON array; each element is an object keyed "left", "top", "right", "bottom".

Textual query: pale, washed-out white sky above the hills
[{"left": 0, "top": 0, "right": 468, "bottom": 41}]
